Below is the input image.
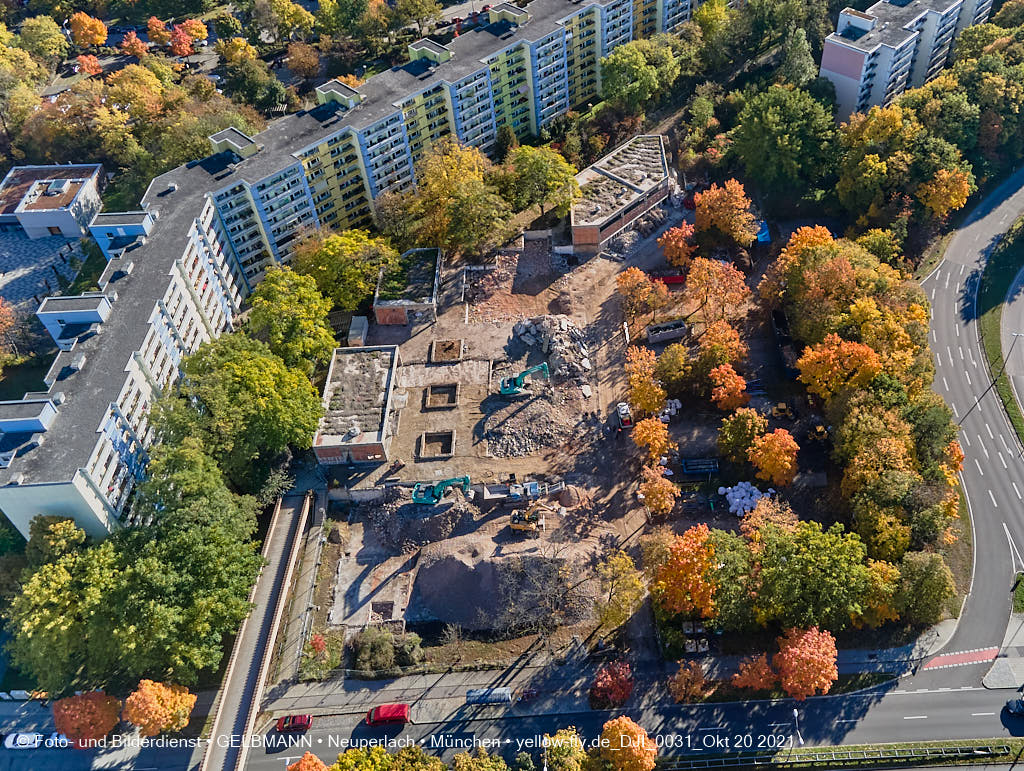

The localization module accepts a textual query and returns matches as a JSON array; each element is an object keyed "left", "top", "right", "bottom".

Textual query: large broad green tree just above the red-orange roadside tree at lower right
[{"left": 756, "top": 522, "right": 869, "bottom": 631}]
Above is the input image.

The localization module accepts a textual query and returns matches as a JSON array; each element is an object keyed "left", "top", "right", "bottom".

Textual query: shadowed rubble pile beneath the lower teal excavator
[{"left": 354, "top": 487, "right": 479, "bottom": 552}]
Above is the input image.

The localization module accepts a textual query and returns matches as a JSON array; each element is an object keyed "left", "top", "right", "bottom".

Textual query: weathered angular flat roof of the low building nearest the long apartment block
[{"left": 572, "top": 134, "right": 669, "bottom": 225}]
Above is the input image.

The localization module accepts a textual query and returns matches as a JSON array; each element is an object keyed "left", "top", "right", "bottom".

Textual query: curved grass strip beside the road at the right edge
[{"left": 978, "top": 219, "right": 1024, "bottom": 441}]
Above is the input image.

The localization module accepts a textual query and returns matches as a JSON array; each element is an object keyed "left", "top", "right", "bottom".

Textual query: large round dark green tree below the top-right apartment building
[{"left": 726, "top": 82, "right": 836, "bottom": 192}]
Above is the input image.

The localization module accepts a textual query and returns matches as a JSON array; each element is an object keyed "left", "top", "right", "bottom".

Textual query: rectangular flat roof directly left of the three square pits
[{"left": 313, "top": 345, "right": 398, "bottom": 447}]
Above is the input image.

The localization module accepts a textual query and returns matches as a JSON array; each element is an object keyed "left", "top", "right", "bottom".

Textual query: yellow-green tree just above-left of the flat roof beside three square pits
[{"left": 246, "top": 264, "right": 335, "bottom": 375}]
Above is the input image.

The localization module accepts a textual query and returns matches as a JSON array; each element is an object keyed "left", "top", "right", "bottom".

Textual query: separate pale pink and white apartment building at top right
[{"left": 821, "top": 0, "right": 992, "bottom": 120}]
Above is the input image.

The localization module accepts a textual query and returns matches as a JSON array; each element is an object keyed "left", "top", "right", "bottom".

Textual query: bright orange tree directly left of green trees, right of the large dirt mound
[{"left": 650, "top": 524, "right": 716, "bottom": 618}]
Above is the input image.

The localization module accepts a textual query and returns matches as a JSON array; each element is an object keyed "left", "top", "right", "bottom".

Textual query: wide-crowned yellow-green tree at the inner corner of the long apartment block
[{"left": 292, "top": 230, "right": 398, "bottom": 310}]
